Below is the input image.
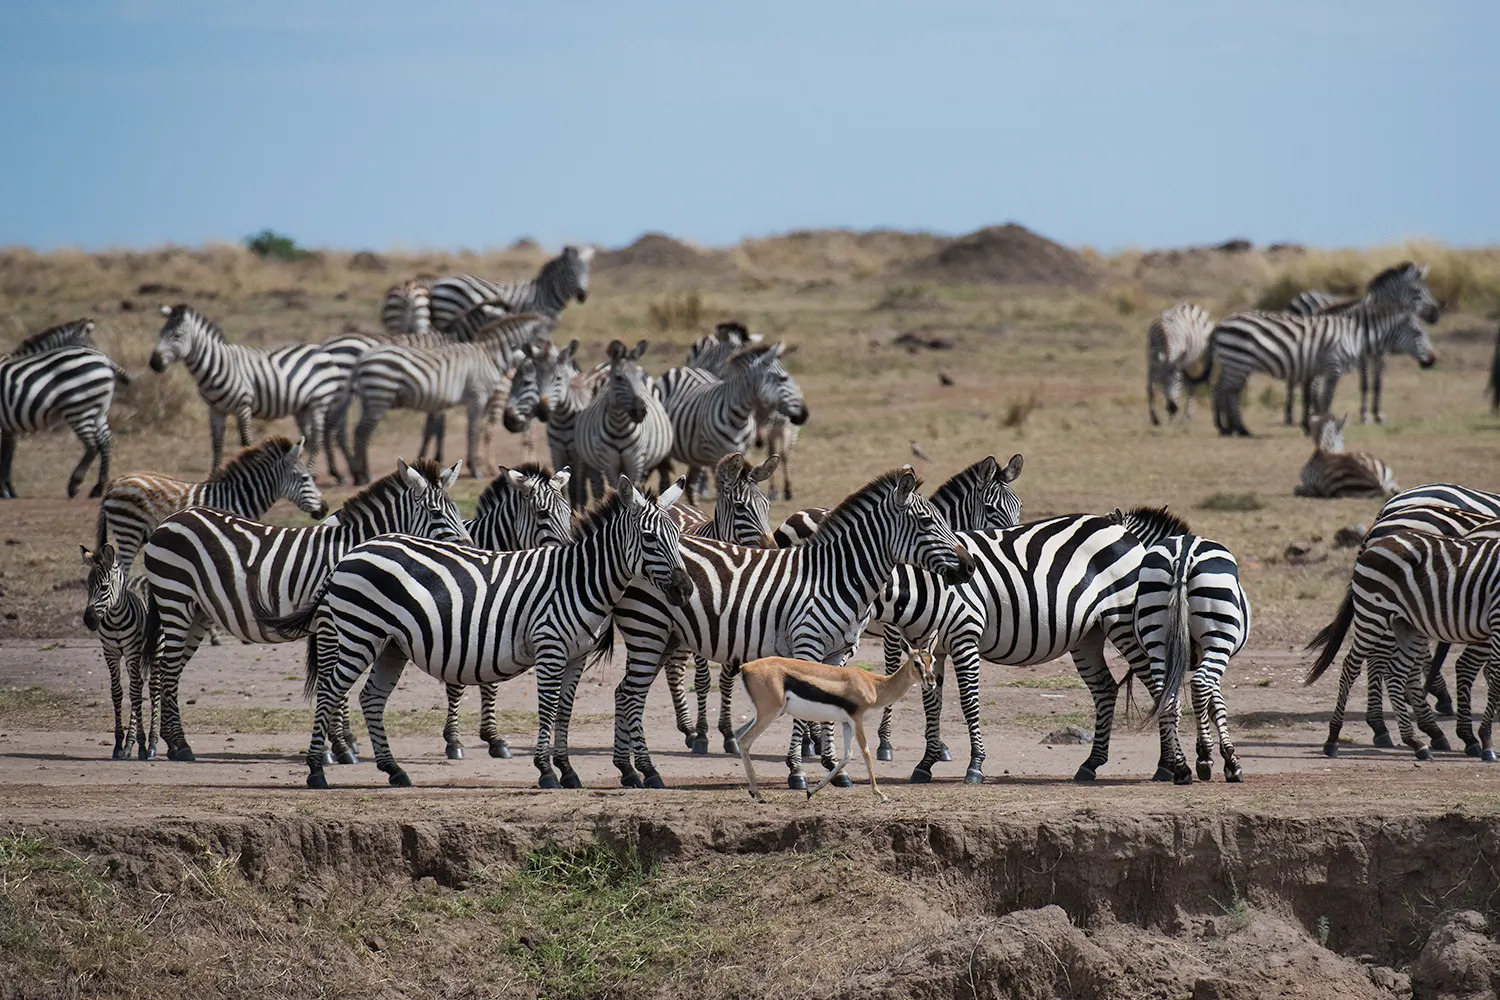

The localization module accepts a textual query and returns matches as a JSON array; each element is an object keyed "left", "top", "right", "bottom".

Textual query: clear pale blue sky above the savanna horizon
[{"left": 0, "top": 0, "right": 1500, "bottom": 249}]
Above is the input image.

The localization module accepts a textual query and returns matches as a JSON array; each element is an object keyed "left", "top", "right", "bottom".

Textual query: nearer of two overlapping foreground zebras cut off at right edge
[{"left": 1307, "top": 525, "right": 1500, "bottom": 760}]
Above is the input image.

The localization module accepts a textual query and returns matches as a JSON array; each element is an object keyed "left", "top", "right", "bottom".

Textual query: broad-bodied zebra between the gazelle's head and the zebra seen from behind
[{"left": 870, "top": 514, "right": 1193, "bottom": 784}]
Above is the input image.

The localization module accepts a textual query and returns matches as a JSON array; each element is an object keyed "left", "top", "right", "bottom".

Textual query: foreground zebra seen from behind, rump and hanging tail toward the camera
[{"left": 1110, "top": 507, "right": 1250, "bottom": 781}]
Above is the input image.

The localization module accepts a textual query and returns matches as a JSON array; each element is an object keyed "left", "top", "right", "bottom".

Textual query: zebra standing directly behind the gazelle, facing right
[{"left": 614, "top": 468, "right": 974, "bottom": 787}]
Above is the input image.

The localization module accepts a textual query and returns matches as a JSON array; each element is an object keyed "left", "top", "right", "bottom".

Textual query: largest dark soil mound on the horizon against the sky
[{"left": 908, "top": 222, "right": 1098, "bottom": 288}]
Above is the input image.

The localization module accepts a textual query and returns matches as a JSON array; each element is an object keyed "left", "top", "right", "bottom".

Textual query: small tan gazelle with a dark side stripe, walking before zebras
[{"left": 735, "top": 649, "right": 938, "bottom": 802}]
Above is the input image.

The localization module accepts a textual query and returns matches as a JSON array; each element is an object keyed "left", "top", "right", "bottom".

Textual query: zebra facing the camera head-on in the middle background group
[{"left": 573, "top": 340, "right": 672, "bottom": 483}]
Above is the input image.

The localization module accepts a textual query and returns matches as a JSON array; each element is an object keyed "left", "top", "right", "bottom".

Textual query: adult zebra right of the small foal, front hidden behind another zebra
[{"left": 146, "top": 459, "right": 468, "bottom": 760}]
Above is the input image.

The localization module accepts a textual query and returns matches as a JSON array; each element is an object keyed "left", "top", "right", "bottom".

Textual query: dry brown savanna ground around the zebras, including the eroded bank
[{"left": 0, "top": 229, "right": 1500, "bottom": 997}]
